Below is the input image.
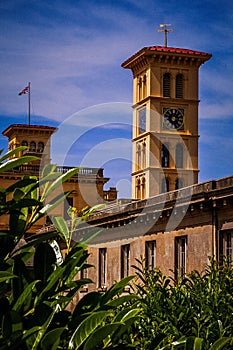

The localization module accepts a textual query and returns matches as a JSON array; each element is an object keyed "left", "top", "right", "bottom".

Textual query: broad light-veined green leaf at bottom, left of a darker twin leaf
[{"left": 68, "top": 311, "right": 109, "bottom": 350}]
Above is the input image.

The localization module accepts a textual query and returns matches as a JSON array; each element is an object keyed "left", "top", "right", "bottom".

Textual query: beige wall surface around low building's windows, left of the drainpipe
[{"left": 82, "top": 225, "right": 212, "bottom": 291}]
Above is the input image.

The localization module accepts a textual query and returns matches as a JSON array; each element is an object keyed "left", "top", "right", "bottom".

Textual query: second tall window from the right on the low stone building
[{"left": 175, "top": 236, "right": 187, "bottom": 278}]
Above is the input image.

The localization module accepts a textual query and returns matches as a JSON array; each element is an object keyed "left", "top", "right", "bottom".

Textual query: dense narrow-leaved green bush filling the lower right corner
[{"left": 134, "top": 259, "right": 233, "bottom": 350}]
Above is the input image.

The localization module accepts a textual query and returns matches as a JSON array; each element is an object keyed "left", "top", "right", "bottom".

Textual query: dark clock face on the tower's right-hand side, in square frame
[{"left": 163, "top": 108, "right": 184, "bottom": 130}]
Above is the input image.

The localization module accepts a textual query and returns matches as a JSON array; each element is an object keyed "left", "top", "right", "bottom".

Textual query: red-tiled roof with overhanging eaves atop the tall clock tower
[{"left": 121, "top": 46, "right": 212, "bottom": 69}]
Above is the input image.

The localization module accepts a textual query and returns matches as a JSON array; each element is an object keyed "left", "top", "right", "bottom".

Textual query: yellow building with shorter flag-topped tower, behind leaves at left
[{"left": 0, "top": 124, "right": 117, "bottom": 233}]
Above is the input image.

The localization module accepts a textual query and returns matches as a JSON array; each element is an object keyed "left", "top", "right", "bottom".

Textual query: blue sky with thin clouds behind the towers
[{"left": 0, "top": 0, "right": 233, "bottom": 197}]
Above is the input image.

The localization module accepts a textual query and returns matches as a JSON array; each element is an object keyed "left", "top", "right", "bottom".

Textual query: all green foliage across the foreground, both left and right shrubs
[{"left": 0, "top": 148, "right": 233, "bottom": 350}]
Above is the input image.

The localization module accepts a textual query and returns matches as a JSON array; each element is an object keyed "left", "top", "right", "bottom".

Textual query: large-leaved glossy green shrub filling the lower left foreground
[{"left": 0, "top": 149, "right": 140, "bottom": 350}]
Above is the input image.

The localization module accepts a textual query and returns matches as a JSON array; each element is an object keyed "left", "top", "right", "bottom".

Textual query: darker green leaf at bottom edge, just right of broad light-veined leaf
[{"left": 83, "top": 322, "right": 122, "bottom": 350}]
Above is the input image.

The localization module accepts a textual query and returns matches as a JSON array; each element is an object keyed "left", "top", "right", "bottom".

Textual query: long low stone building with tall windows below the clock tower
[{"left": 74, "top": 176, "right": 233, "bottom": 290}]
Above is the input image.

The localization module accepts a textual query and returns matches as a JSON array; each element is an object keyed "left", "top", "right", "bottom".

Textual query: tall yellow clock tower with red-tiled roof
[{"left": 122, "top": 46, "right": 211, "bottom": 199}]
